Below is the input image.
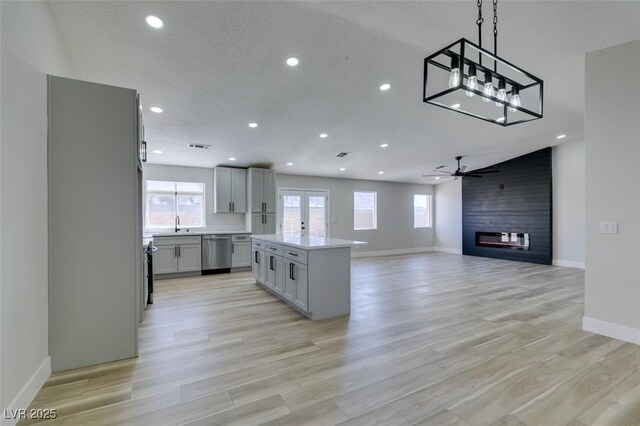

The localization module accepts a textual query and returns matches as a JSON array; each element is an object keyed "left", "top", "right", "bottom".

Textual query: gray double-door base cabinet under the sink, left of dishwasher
[{"left": 153, "top": 236, "right": 202, "bottom": 278}]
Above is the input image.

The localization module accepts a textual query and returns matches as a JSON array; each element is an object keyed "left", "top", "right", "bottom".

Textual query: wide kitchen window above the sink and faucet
[{"left": 145, "top": 180, "right": 205, "bottom": 229}]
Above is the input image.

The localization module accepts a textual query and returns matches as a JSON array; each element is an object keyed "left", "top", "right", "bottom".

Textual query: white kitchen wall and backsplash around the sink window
[{"left": 143, "top": 164, "right": 245, "bottom": 231}]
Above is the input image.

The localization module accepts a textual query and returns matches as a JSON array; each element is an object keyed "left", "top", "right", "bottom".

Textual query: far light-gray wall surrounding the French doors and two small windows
[{"left": 276, "top": 174, "right": 433, "bottom": 252}]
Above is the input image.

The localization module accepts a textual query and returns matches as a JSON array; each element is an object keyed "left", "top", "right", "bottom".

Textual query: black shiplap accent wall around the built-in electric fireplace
[{"left": 462, "top": 148, "right": 553, "bottom": 265}]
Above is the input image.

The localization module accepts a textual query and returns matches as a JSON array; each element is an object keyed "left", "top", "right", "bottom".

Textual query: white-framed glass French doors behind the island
[{"left": 278, "top": 190, "right": 329, "bottom": 238}]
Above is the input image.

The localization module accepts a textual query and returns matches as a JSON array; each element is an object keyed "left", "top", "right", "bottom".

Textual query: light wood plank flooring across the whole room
[{"left": 23, "top": 253, "right": 640, "bottom": 426}]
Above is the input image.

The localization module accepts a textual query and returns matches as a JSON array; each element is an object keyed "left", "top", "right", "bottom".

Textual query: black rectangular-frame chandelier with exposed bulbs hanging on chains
[{"left": 422, "top": 0, "right": 544, "bottom": 127}]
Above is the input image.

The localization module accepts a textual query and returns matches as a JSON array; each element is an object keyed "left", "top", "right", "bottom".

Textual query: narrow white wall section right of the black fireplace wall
[{"left": 553, "top": 139, "right": 586, "bottom": 268}]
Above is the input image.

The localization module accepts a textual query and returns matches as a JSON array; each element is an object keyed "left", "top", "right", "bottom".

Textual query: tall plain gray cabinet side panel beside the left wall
[{"left": 48, "top": 76, "right": 143, "bottom": 371}]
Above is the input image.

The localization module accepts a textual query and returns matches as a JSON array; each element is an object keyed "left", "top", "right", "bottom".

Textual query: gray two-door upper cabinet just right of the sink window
[{"left": 213, "top": 167, "right": 247, "bottom": 213}]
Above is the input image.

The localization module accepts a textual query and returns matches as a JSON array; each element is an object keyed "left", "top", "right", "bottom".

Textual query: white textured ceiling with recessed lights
[{"left": 51, "top": 1, "right": 640, "bottom": 183}]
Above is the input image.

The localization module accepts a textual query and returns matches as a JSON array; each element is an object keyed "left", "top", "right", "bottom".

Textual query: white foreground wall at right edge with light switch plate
[{"left": 583, "top": 41, "right": 640, "bottom": 344}]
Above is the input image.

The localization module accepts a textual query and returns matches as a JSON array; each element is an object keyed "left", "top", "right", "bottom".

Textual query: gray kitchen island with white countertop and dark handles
[{"left": 251, "top": 235, "right": 364, "bottom": 321}]
